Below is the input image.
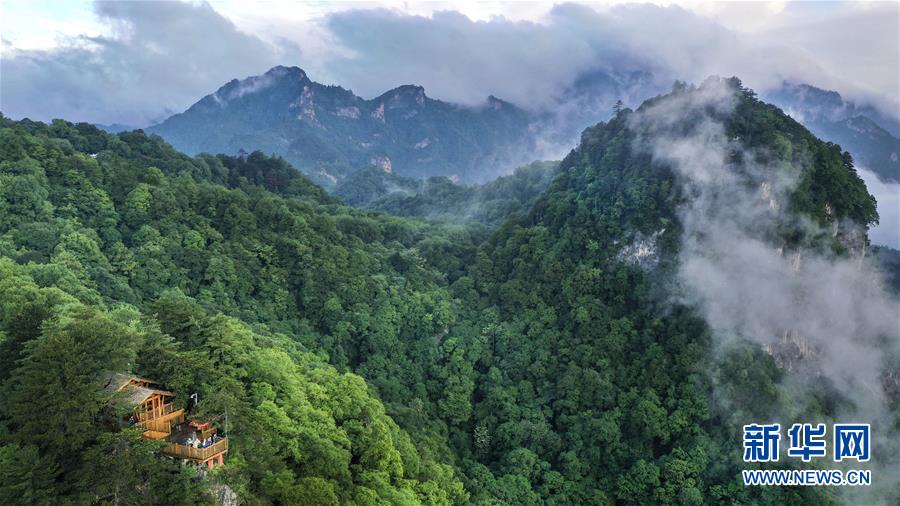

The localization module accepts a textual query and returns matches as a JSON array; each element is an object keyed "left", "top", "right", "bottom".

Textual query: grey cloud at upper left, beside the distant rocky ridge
[{"left": 0, "top": 2, "right": 300, "bottom": 126}]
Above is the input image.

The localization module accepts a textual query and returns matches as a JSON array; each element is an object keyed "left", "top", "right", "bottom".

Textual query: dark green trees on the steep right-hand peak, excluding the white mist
[{"left": 446, "top": 80, "right": 875, "bottom": 504}]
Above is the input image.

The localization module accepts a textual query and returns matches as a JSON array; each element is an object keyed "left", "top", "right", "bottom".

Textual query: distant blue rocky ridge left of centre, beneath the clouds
[{"left": 147, "top": 67, "right": 535, "bottom": 187}]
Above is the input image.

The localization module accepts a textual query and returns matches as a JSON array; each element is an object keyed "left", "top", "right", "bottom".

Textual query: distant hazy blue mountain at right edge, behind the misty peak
[{"left": 766, "top": 83, "right": 900, "bottom": 182}]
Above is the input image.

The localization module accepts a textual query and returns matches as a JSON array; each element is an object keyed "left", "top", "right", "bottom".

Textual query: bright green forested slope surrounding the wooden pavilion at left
[{"left": 0, "top": 119, "right": 474, "bottom": 504}]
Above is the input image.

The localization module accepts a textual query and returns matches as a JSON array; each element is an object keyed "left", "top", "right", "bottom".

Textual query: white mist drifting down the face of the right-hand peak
[{"left": 630, "top": 80, "right": 900, "bottom": 502}]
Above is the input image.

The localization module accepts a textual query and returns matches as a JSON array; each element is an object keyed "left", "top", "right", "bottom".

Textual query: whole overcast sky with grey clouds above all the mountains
[{"left": 0, "top": 0, "right": 900, "bottom": 126}]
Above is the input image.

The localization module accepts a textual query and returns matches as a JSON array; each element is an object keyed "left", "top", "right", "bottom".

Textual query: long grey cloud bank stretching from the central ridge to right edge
[{"left": 324, "top": 4, "right": 900, "bottom": 114}]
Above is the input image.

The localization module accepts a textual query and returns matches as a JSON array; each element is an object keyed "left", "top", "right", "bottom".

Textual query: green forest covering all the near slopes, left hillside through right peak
[{"left": 0, "top": 79, "right": 900, "bottom": 505}]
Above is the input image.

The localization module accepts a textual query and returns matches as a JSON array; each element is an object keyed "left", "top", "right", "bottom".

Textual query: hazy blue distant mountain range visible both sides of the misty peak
[{"left": 144, "top": 66, "right": 900, "bottom": 190}]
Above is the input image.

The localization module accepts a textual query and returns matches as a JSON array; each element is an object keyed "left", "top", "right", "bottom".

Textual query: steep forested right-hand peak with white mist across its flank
[{"left": 468, "top": 79, "right": 898, "bottom": 504}]
